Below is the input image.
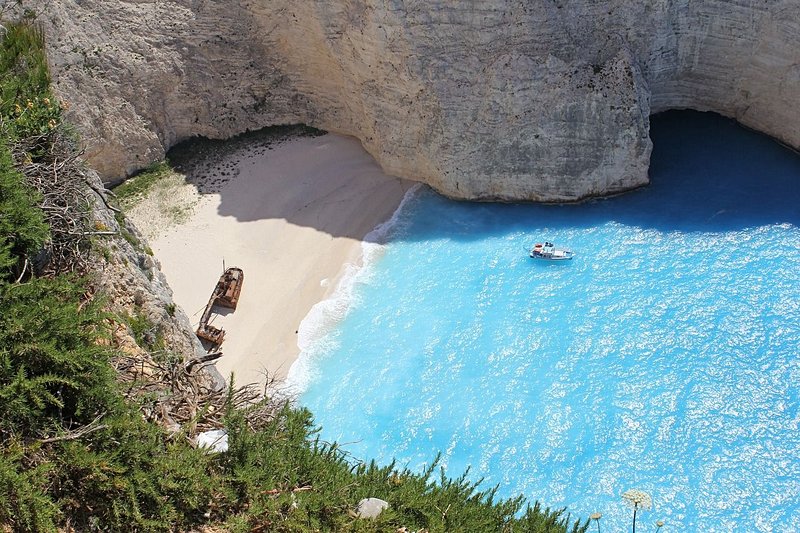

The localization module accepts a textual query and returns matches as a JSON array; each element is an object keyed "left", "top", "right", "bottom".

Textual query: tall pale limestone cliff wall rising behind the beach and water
[{"left": 25, "top": 0, "right": 800, "bottom": 201}]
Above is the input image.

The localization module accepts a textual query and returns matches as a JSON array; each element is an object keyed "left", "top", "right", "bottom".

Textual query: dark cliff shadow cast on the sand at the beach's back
[{"left": 167, "top": 125, "right": 411, "bottom": 240}]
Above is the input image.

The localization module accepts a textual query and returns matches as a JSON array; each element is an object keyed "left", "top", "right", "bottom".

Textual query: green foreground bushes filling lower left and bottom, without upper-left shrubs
[{"left": 0, "top": 272, "right": 580, "bottom": 532}]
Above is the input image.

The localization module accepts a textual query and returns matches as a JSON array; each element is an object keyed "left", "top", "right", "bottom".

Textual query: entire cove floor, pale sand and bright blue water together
[{"left": 128, "top": 113, "right": 800, "bottom": 531}]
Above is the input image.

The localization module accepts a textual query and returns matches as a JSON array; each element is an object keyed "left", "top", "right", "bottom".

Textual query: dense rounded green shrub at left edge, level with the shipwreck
[{"left": 0, "top": 278, "right": 114, "bottom": 438}]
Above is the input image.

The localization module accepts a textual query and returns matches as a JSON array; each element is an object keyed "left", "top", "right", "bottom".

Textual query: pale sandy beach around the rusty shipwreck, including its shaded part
[{"left": 129, "top": 129, "right": 413, "bottom": 385}]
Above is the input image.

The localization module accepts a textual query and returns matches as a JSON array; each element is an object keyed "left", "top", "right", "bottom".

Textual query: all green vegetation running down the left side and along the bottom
[{"left": 0, "top": 18, "right": 587, "bottom": 532}]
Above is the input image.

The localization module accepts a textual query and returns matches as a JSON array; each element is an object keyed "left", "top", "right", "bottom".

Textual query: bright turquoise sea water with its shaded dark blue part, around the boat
[{"left": 292, "top": 112, "right": 800, "bottom": 531}]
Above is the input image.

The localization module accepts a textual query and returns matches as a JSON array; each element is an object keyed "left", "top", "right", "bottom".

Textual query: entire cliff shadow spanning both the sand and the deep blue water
[{"left": 168, "top": 111, "right": 800, "bottom": 245}]
